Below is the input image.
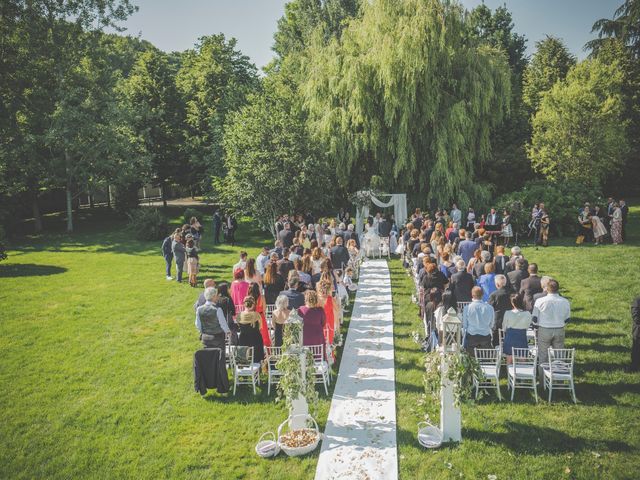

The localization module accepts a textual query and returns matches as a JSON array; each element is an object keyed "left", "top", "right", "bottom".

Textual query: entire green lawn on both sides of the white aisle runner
[{"left": 0, "top": 209, "right": 640, "bottom": 480}]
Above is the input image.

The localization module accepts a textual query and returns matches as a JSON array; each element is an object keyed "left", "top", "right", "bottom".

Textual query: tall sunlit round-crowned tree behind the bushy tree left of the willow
[{"left": 176, "top": 34, "right": 259, "bottom": 196}]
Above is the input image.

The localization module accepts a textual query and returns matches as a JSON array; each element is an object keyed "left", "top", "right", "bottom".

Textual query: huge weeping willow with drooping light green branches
[{"left": 301, "top": 0, "right": 511, "bottom": 205}]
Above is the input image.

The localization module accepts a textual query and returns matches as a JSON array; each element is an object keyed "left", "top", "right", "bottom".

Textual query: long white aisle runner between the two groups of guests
[{"left": 315, "top": 260, "right": 398, "bottom": 480}]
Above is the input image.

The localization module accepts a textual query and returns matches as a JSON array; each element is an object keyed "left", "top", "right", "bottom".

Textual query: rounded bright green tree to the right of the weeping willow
[{"left": 528, "top": 59, "right": 628, "bottom": 188}]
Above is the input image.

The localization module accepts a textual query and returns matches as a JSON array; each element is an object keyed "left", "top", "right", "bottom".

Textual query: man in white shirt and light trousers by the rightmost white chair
[{"left": 533, "top": 280, "right": 571, "bottom": 364}]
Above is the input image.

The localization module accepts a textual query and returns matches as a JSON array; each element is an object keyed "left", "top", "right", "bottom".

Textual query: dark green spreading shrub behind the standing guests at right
[{"left": 496, "top": 180, "right": 604, "bottom": 236}]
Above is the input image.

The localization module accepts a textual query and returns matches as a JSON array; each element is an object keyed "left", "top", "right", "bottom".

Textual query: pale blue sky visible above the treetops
[{"left": 112, "top": 0, "right": 622, "bottom": 68}]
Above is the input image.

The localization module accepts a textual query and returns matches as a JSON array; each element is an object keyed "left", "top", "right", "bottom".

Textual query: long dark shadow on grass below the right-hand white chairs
[{"left": 462, "top": 421, "right": 631, "bottom": 455}]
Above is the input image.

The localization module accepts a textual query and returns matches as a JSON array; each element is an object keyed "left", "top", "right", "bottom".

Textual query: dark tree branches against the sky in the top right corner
[{"left": 585, "top": 0, "right": 640, "bottom": 59}]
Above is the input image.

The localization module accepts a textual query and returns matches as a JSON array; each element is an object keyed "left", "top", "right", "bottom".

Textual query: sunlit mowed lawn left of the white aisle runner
[{"left": 0, "top": 210, "right": 348, "bottom": 480}]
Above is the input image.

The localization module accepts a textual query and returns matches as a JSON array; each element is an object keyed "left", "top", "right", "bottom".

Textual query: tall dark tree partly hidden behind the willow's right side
[{"left": 468, "top": 4, "right": 531, "bottom": 193}]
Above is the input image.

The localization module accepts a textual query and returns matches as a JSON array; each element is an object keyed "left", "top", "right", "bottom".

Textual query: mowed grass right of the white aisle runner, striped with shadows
[{"left": 389, "top": 207, "right": 640, "bottom": 479}]
